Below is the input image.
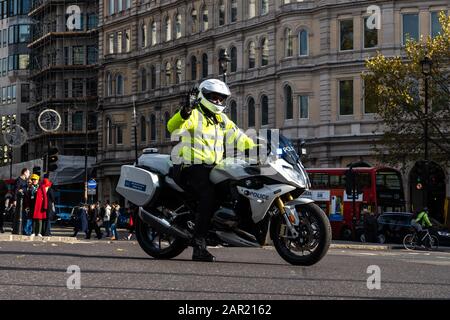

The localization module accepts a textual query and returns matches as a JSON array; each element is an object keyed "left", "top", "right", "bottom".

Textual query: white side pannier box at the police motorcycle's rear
[{"left": 116, "top": 166, "right": 159, "bottom": 206}]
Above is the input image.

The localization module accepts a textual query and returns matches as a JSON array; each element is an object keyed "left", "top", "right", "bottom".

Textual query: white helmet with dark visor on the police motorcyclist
[{"left": 198, "top": 79, "right": 231, "bottom": 113}]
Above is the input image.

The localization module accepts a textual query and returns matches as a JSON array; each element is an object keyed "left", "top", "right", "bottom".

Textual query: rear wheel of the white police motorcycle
[{"left": 136, "top": 215, "right": 187, "bottom": 260}]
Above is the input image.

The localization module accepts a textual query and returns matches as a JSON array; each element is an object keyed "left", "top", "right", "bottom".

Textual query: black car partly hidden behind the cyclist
[{"left": 377, "top": 212, "right": 450, "bottom": 246}]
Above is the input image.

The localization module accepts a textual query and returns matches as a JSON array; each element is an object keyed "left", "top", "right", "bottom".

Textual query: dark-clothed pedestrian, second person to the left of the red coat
[{"left": 12, "top": 168, "right": 30, "bottom": 235}]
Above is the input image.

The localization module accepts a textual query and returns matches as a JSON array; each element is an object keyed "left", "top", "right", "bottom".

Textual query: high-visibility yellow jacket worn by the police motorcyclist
[{"left": 167, "top": 107, "right": 256, "bottom": 164}]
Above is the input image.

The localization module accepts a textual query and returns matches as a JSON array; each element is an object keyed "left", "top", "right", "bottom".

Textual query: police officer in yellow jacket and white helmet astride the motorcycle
[{"left": 167, "top": 79, "right": 256, "bottom": 262}]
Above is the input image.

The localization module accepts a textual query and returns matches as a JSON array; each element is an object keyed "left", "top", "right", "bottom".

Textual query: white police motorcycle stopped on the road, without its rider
[{"left": 116, "top": 136, "right": 331, "bottom": 266}]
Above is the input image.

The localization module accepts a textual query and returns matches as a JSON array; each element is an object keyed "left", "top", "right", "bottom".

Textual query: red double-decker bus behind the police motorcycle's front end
[{"left": 302, "top": 167, "right": 405, "bottom": 240}]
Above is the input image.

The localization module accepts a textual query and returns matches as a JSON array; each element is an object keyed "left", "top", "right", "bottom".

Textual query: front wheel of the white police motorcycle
[{"left": 270, "top": 203, "right": 331, "bottom": 266}]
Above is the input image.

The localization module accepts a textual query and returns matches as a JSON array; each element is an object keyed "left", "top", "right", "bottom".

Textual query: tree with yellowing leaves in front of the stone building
[{"left": 363, "top": 13, "right": 450, "bottom": 165}]
